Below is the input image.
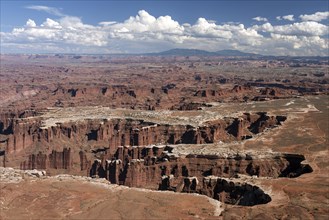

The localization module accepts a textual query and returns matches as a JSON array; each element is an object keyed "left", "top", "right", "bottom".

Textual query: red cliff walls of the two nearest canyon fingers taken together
[{"left": 82, "top": 146, "right": 312, "bottom": 206}]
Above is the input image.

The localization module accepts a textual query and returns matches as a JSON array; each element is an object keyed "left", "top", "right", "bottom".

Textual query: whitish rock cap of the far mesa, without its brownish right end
[{"left": 40, "top": 106, "right": 231, "bottom": 128}]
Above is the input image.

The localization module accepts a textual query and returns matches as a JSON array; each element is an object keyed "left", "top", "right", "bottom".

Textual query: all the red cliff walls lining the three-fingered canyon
[{"left": 1, "top": 109, "right": 312, "bottom": 205}]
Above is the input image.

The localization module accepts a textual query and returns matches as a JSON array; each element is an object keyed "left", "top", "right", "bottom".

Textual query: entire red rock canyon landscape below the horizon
[{"left": 0, "top": 56, "right": 329, "bottom": 219}]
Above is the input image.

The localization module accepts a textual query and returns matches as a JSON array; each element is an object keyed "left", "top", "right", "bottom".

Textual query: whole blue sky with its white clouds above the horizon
[{"left": 0, "top": 0, "right": 329, "bottom": 56}]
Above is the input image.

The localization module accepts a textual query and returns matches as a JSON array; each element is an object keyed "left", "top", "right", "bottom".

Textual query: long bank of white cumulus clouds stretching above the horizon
[{"left": 0, "top": 8, "right": 329, "bottom": 56}]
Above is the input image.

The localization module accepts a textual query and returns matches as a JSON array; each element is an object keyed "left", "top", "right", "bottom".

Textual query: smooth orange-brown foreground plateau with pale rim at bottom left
[{"left": 0, "top": 170, "right": 221, "bottom": 219}]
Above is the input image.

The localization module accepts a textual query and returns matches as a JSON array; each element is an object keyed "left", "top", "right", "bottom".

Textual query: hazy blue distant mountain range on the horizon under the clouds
[{"left": 145, "top": 48, "right": 261, "bottom": 57}]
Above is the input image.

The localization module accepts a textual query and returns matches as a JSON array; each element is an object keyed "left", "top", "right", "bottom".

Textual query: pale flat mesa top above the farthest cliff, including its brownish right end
[{"left": 37, "top": 97, "right": 318, "bottom": 129}]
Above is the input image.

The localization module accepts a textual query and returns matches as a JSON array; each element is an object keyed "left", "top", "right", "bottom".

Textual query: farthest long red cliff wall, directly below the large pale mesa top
[{"left": 2, "top": 112, "right": 286, "bottom": 154}]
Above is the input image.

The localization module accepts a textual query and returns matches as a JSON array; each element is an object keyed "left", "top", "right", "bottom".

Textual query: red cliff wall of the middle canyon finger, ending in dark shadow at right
[{"left": 90, "top": 146, "right": 312, "bottom": 191}]
